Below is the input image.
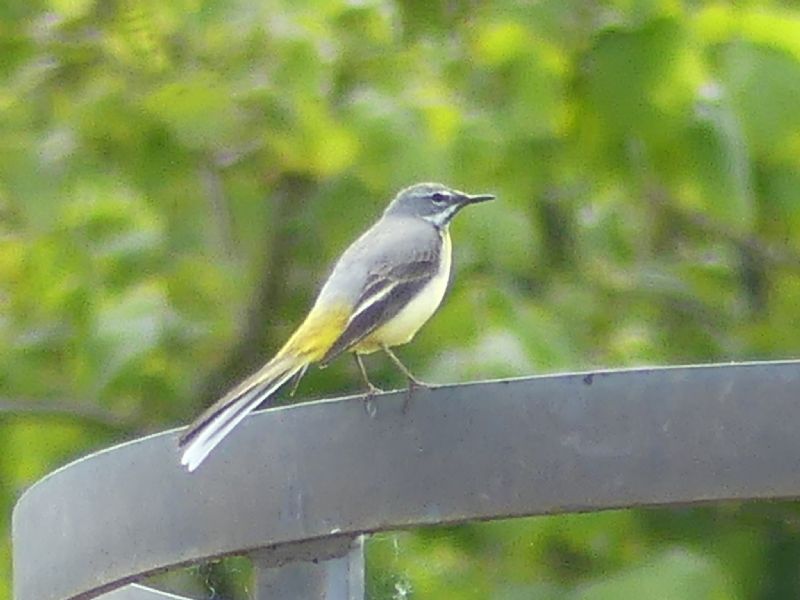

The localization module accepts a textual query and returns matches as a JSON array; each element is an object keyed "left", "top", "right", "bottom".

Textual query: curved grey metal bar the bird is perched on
[{"left": 13, "top": 362, "right": 800, "bottom": 600}]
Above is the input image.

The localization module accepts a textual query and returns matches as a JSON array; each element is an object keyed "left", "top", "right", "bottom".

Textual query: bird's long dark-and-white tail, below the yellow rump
[{"left": 179, "top": 355, "right": 309, "bottom": 471}]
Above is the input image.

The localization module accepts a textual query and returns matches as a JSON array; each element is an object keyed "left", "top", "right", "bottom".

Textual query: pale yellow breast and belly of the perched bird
[{"left": 352, "top": 229, "right": 452, "bottom": 354}]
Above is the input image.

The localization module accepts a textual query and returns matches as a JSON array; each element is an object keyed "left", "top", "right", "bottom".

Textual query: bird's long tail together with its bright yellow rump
[{"left": 179, "top": 306, "right": 349, "bottom": 471}]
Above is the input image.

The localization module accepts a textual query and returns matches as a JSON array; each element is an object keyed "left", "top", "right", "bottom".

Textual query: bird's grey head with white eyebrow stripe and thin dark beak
[{"left": 384, "top": 183, "right": 494, "bottom": 229}]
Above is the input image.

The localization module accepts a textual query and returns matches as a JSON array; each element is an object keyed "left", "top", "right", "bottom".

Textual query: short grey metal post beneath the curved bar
[{"left": 250, "top": 537, "right": 364, "bottom": 600}]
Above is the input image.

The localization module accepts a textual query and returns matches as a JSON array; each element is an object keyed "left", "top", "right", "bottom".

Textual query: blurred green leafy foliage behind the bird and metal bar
[{"left": 0, "top": 0, "right": 800, "bottom": 600}]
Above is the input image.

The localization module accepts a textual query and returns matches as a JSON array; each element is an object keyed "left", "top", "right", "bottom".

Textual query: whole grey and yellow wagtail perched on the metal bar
[{"left": 180, "top": 183, "right": 494, "bottom": 471}]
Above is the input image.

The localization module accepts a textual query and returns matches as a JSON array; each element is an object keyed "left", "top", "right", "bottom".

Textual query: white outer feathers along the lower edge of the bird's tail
[{"left": 181, "top": 360, "right": 307, "bottom": 472}]
